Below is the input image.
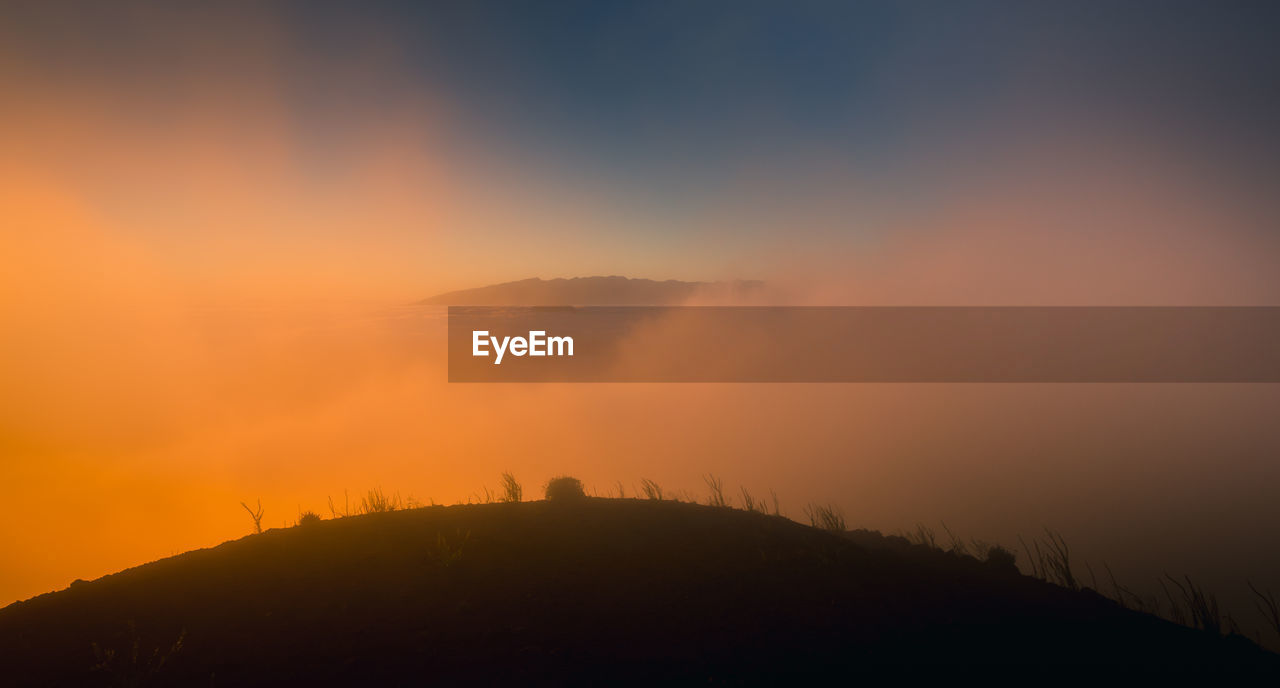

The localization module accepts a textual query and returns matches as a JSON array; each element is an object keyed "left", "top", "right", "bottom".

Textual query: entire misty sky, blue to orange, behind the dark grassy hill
[{"left": 0, "top": 1, "right": 1280, "bottom": 639}]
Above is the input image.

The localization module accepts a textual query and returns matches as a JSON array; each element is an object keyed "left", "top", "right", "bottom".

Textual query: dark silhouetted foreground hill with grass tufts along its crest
[{"left": 0, "top": 499, "right": 1280, "bottom": 685}]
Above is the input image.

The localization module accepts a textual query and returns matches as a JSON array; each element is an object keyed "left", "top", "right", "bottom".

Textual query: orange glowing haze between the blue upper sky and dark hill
[{"left": 0, "top": 2, "right": 1280, "bottom": 634}]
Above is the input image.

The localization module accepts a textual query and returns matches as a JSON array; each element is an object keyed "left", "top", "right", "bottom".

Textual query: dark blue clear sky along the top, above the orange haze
[{"left": 267, "top": 1, "right": 1280, "bottom": 191}]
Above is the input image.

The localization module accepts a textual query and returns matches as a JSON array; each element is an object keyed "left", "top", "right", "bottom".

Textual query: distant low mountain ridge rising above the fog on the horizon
[{"left": 419, "top": 275, "right": 764, "bottom": 306}]
